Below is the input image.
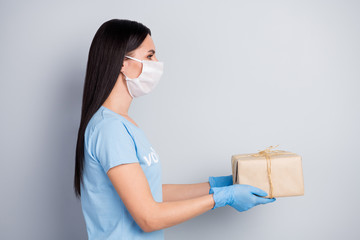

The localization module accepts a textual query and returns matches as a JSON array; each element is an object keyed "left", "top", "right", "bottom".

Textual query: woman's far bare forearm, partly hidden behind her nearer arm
[{"left": 162, "top": 182, "right": 210, "bottom": 202}]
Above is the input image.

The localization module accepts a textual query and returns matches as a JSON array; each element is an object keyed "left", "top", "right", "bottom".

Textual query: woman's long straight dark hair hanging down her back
[{"left": 74, "top": 19, "right": 151, "bottom": 198}]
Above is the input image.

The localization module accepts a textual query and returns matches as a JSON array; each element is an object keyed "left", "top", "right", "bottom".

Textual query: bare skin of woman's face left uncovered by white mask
[{"left": 121, "top": 34, "right": 158, "bottom": 78}]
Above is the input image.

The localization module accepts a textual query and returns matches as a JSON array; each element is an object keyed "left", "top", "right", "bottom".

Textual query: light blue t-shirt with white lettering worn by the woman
[{"left": 81, "top": 106, "right": 164, "bottom": 240}]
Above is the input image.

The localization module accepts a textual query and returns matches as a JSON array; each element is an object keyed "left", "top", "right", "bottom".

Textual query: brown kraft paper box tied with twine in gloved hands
[{"left": 231, "top": 146, "right": 304, "bottom": 198}]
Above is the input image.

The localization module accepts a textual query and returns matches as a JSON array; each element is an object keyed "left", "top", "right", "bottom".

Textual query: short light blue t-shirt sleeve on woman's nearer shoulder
[{"left": 93, "top": 119, "right": 139, "bottom": 173}]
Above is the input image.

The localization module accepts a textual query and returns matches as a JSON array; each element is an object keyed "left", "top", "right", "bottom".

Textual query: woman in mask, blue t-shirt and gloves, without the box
[{"left": 74, "top": 19, "right": 275, "bottom": 240}]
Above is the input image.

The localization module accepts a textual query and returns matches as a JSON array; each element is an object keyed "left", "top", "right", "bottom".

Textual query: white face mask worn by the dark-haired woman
[{"left": 124, "top": 56, "right": 164, "bottom": 98}]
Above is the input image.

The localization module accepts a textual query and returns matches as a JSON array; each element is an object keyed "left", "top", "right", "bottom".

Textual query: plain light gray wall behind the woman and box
[{"left": 0, "top": 0, "right": 360, "bottom": 240}]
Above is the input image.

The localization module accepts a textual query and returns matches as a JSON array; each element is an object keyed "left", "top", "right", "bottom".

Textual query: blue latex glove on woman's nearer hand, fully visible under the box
[{"left": 209, "top": 184, "right": 276, "bottom": 212}]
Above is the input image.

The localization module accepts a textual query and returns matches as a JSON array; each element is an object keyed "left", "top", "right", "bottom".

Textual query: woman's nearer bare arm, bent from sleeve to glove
[{"left": 107, "top": 163, "right": 215, "bottom": 232}]
